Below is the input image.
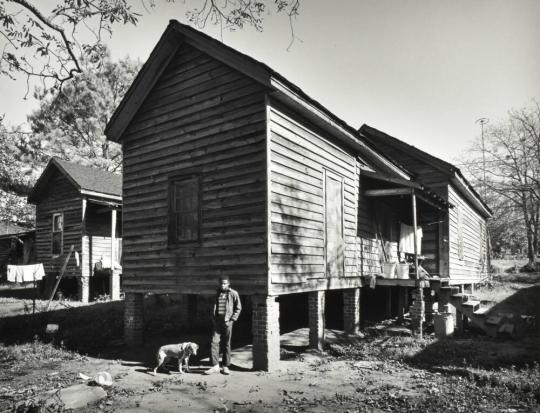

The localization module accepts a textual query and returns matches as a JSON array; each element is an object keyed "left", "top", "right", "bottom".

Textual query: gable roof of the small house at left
[{"left": 28, "top": 158, "right": 122, "bottom": 203}]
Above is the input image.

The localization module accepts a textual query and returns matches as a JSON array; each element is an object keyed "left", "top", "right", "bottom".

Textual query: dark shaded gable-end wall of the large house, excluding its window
[{"left": 122, "top": 44, "right": 267, "bottom": 294}]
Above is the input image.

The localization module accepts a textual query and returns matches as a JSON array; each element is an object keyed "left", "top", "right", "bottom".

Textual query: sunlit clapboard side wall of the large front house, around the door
[{"left": 269, "top": 104, "right": 359, "bottom": 294}]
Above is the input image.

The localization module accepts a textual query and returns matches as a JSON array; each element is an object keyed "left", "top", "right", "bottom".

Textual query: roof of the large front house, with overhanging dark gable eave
[{"left": 105, "top": 20, "right": 410, "bottom": 180}]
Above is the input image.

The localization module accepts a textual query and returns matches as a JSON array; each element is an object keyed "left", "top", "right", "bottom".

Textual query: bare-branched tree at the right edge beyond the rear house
[{"left": 460, "top": 102, "right": 540, "bottom": 264}]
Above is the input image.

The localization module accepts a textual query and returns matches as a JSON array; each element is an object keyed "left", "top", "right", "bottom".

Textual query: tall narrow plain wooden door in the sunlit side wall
[{"left": 325, "top": 171, "right": 345, "bottom": 277}]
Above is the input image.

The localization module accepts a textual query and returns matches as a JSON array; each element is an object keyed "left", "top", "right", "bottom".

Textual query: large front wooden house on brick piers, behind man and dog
[{"left": 106, "top": 21, "right": 490, "bottom": 369}]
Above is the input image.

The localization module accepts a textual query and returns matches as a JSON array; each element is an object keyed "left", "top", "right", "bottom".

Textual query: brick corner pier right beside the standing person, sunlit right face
[{"left": 251, "top": 295, "right": 280, "bottom": 371}]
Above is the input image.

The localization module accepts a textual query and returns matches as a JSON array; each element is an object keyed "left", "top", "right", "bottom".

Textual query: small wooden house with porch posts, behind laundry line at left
[{"left": 28, "top": 158, "right": 122, "bottom": 302}]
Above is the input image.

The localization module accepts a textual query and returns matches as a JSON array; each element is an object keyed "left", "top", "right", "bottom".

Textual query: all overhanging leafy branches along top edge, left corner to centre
[{"left": 0, "top": 0, "right": 300, "bottom": 93}]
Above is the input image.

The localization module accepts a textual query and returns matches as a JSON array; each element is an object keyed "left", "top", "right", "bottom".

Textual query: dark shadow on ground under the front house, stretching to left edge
[{"left": 0, "top": 301, "right": 251, "bottom": 367}]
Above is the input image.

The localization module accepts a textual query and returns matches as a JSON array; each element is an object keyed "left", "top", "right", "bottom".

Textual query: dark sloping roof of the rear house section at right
[{"left": 358, "top": 124, "right": 493, "bottom": 217}]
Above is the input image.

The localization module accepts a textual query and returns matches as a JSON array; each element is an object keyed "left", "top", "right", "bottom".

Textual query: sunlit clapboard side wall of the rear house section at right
[{"left": 448, "top": 185, "right": 487, "bottom": 279}]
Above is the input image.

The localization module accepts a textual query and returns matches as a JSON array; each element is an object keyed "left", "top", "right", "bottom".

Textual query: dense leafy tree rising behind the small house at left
[{"left": 24, "top": 49, "right": 140, "bottom": 172}]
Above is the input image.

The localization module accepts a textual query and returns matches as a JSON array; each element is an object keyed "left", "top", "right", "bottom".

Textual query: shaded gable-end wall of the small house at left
[{"left": 36, "top": 173, "right": 82, "bottom": 276}]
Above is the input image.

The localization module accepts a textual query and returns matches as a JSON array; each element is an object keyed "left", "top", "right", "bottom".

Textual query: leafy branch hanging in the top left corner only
[{"left": 0, "top": 0, "right": 140, "bottom": 91}]
